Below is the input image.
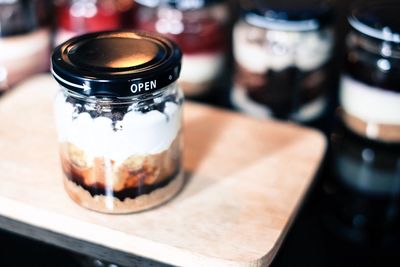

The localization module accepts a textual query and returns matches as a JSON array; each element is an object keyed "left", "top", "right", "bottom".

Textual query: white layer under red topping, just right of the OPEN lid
[{"left": 179, "top": 51, "right": 225, "bottom": 84}]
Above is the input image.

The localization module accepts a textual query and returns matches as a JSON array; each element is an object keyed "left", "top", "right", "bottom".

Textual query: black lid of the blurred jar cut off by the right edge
[{"left": 348, "top": 0, "right": 400, "bottom": 43}]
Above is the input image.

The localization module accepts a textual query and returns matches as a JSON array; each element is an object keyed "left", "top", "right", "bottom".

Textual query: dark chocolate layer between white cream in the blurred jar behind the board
[{"left": 235, "top": 62, "right": 331, "bottom": 118}]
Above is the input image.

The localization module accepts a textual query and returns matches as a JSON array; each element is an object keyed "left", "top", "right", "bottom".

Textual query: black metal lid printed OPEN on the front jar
[{"left": 51, "top": 31, "right": 182, "bottom": 97}]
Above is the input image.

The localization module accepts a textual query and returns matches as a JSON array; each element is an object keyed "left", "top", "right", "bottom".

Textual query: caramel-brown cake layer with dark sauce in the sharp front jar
[{"left": 61, "top": 135, "right": 181, "bottom": 207}]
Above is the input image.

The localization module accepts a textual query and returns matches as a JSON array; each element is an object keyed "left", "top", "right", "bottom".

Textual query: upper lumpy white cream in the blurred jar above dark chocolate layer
[{"left": 233, "top": 22, "right": 334, "bottom": 74}]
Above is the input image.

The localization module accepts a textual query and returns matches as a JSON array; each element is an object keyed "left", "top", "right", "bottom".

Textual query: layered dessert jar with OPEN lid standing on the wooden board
[{"left": 52, "top": 31, "right": 183, "bottom": 213}]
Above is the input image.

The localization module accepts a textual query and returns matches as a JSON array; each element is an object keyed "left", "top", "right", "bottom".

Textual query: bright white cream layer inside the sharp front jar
[{"left": 55, "top": 93, "right": 182, "bottom": 162}]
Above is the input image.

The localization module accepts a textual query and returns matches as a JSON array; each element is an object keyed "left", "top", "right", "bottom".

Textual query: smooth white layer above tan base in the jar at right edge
[{"left": 339, "top": 76, "right": 400, "bottom": 125}]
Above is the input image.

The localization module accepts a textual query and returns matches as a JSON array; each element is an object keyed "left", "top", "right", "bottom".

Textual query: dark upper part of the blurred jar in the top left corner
[{"left": 0, "top": 0, "right": 38, "bottom": 37}]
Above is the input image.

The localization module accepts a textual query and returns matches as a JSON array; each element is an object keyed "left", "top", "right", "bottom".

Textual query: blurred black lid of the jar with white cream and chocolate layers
[{"left": 244, "top": 0, "right": 333, "bottom": 31}]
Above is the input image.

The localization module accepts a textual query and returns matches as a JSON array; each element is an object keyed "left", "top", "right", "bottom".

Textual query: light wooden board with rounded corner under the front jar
[{"left": 0, "top": 75, "right": 326, "bottom": 266}]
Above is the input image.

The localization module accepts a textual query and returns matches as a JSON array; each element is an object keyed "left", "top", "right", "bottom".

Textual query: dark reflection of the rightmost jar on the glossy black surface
[{"left": 325, "top": 122, "right": 400, "bottom": 245}]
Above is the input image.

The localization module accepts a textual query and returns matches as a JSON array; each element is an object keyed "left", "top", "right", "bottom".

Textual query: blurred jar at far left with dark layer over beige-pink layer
[{"left": 0, "top": 0, "right": 50, "bottom": 92}]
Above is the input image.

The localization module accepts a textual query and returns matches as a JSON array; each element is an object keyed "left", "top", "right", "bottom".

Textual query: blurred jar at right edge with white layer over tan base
[{"left": 339, "top": 1, "right": 400, "bottom": 142}]
